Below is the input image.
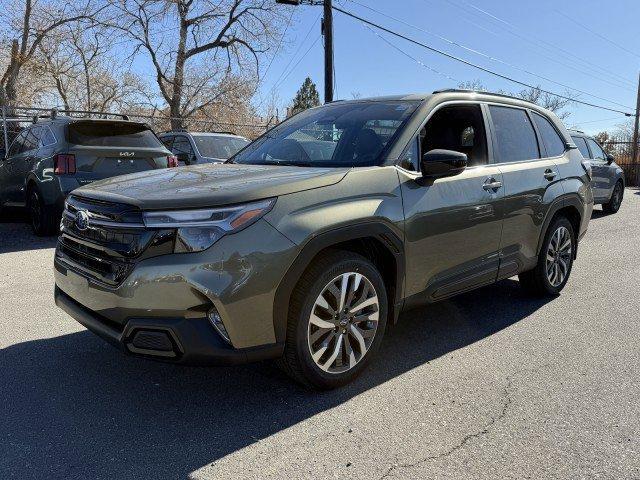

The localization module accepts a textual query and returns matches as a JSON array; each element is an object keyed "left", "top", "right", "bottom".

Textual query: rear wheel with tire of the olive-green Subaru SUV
[{"left": 518, "top": 216, "right": 576, "bottom": 296}]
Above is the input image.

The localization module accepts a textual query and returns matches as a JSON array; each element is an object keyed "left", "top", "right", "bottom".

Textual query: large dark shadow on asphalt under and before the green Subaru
[{"left": 0, "top": 280, "right": 547, "bottom": 479}]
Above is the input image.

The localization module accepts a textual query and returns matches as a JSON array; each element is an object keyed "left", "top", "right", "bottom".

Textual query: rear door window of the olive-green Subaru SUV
[{"left": 489, "top": 105, "right": 540, "bottom": 163}]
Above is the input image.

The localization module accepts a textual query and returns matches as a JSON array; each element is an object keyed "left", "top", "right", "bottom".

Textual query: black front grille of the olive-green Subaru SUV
[{"left": 56, "top": 195, "right": 173, "bottom": 286}]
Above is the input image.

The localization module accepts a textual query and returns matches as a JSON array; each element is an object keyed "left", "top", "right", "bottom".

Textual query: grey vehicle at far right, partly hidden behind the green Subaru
[{"left": 570, "top": 130, "right": 625, "bottom": 213}]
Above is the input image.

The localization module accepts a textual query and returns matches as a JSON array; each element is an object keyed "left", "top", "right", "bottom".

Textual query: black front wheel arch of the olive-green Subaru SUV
[{"left": 273, "top": 222, "right": 405, "bottom": 342}]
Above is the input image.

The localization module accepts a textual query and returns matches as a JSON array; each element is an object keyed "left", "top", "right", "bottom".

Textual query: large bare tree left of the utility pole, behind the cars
[{"left": 109, "top": 0, "right": 285, "bottom": 128}]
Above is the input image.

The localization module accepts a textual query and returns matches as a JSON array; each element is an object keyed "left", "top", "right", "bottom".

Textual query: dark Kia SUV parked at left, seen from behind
[{"left": 0, "top": 111, "right": 177, "bottom": 235}]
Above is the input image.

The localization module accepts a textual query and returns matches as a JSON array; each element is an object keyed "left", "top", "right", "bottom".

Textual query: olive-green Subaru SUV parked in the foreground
[{"left": 55, "top": 91, "right": 593, "bottom": 389}]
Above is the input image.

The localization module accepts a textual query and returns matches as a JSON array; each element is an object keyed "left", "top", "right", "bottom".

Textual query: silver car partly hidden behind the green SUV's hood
[{"left": 159, "top": 130, "right": 250, "bottom": 165}]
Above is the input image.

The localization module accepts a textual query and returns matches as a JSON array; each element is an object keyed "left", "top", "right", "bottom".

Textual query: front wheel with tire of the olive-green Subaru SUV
[{"left": 279, "top": 251, "right": 388, "bottom": 390}]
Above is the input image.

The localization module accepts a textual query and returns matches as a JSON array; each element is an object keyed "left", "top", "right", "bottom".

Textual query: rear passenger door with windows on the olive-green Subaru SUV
[{"left": 488, "top": 104, "right": 565, "bottom": 278}]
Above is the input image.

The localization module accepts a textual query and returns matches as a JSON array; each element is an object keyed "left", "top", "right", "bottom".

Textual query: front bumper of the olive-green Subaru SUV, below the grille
[{"left": 54, "top": 220, "right": 297, "bottom": 365}]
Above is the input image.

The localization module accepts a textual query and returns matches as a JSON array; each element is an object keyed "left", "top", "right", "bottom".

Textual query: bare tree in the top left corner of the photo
[{"left": 0, "top": 0, "right": 105, "bottom": 106}]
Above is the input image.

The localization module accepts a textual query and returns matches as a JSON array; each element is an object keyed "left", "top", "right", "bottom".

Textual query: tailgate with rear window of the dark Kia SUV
[{"left": 65, "top": 120, "right": 169, "bottom": 184}]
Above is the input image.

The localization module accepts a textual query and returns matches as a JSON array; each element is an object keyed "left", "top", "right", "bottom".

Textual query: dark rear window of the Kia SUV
[{"left": 68, "top": 122, "right": 162, "bottom": 148}]
